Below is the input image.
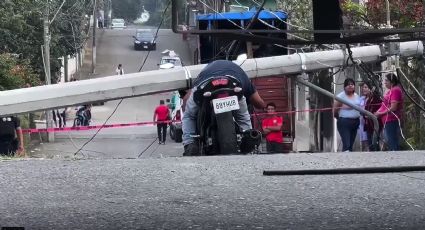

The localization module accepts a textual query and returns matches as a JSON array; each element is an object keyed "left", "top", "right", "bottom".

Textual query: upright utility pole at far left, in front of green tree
[{"left": 43, "top": 2, "right": 55, "bottom": 142}]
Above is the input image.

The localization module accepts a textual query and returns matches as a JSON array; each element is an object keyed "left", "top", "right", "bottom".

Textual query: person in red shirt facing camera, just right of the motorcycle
[{"left": 262, "top": 103, "right": 283, "bottom": 153}]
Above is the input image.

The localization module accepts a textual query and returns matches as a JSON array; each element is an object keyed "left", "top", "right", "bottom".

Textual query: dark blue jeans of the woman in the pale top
[{"left": 336, "top": 117, "right": 360, "bottom": 152}]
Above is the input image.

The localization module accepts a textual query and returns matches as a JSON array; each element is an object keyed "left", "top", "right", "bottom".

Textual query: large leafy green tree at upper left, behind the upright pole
[{"left": 0, "top": 0, "right": 92, "bottom": 82}]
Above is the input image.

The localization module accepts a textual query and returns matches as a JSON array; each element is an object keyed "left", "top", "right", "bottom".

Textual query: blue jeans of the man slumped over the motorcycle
[{"left": 182, "top": 88, "right": 252, "bottom": 145}]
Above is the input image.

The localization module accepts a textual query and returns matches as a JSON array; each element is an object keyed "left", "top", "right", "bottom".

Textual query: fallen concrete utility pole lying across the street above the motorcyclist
[{"left": 0, "top": 41, "right": 424, "bottom": 115}]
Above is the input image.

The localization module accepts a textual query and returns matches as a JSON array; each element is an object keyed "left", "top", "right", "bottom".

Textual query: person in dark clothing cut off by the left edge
[{"left": 0, "top": 116, "right": 24, "bottom": 156}]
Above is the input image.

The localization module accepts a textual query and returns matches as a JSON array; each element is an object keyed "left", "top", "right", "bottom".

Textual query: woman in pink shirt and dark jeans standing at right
[{"left": 375, "top": 74, "right": 403, "bottom": 151}]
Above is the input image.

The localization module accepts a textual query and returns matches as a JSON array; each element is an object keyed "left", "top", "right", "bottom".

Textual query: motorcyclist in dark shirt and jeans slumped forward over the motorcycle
[{"left": 182, "top": 60, "right": 266, "bottom": 156}]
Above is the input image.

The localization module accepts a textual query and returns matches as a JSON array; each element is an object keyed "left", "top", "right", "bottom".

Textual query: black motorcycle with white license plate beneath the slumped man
[{"left": 193, "top": 75, "right": 261, "bottom": 155}]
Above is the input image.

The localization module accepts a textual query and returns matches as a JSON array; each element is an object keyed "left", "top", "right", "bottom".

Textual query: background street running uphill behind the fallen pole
[{"left": 30, "top": 28, "right": 192, "bottom": 159}]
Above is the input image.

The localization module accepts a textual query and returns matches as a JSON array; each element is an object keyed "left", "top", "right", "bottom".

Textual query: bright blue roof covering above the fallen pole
[{"left": 197, "top": 9, "right": 288, "bottom": 20}]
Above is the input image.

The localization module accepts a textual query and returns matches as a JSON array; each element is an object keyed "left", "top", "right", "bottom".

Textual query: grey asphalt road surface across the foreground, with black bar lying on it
[{"left": 0, "top": 152, "right": 425, "bottom": 229}]
